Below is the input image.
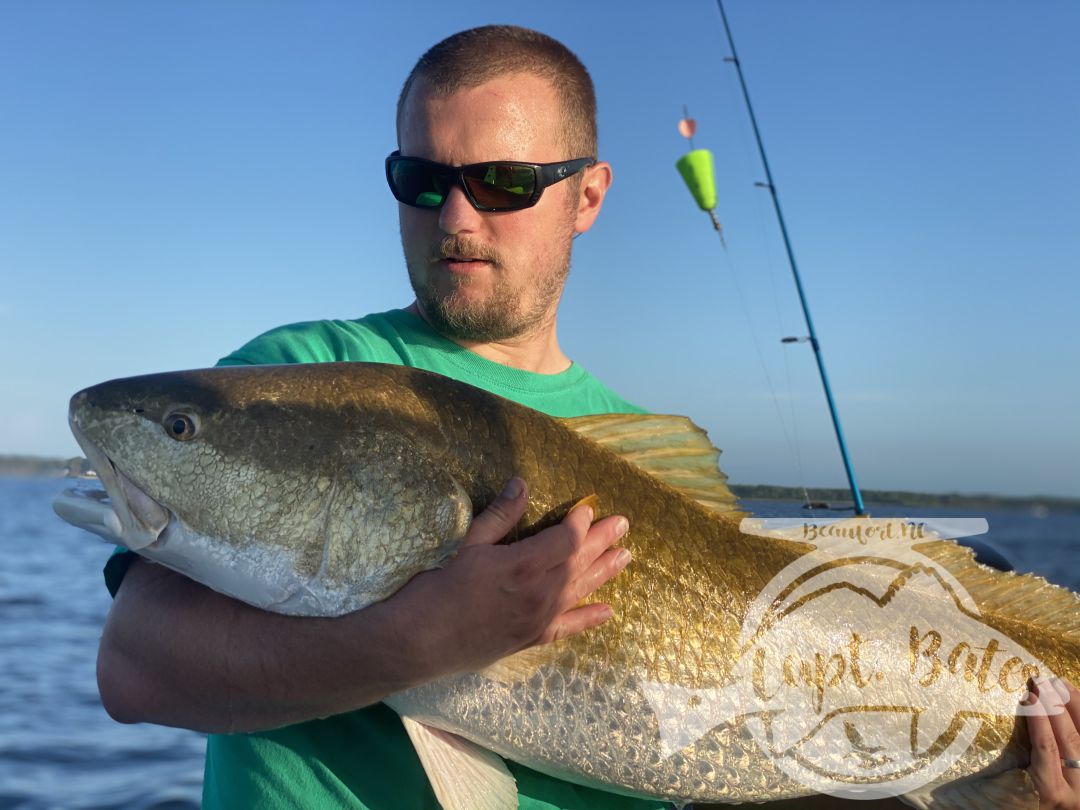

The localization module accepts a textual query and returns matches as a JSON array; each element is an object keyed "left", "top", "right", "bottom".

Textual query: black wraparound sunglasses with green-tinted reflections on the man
[{"left": 387, "top": 151, "right": 596, "bottom": 211}]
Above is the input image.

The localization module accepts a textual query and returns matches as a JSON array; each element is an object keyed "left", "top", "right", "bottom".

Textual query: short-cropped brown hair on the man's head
[{"left": 397, "top": 25, "right": 597, "bottom": 159}]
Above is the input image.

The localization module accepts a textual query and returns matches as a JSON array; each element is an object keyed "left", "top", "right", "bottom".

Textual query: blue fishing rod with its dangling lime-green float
[{"left": 676, "top": 0, "right": 866, "bottom": 515}]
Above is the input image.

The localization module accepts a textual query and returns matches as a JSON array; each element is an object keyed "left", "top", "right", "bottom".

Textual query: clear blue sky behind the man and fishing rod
[{"left": 0, "top": 0, "right": 1080, "bottom": 496}]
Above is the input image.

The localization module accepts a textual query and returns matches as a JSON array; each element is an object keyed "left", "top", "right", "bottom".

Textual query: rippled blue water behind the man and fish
[{"left": 0, "top": 478, "right": 1080, "bottom": 810}]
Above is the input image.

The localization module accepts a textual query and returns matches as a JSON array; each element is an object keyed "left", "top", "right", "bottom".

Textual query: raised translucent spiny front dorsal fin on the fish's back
[{"left": 562, "top": 414, "right": 742, "bottom": 516}]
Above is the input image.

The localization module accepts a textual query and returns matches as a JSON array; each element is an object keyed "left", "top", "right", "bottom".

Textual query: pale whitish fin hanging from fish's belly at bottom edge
[{"left": 402, "top": 716, "right": 517, "bottom": 810}]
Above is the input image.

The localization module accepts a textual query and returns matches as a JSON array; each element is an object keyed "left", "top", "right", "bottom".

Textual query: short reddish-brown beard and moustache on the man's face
[{"left": 408, "top": 231, "right": 570, "bottom": 342}]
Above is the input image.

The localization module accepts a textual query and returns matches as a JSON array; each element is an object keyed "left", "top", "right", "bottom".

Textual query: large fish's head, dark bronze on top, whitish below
[{"left": 54, "top": 366, "right": 472, "bottom": 615}]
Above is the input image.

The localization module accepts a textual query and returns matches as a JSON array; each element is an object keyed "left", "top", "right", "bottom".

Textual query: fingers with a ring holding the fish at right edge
[{"left": 1027, "top": 678, "right": 1080, "bottom": 810}]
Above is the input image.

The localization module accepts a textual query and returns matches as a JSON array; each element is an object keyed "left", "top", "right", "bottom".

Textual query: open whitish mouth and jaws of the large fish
[{"left": 53, "top": 408, "right": 171, "bottom": 551}]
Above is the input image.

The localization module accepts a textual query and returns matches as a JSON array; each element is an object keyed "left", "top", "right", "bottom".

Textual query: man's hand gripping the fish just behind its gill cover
[{"left": 393, "top": 478, "right": 630, "bottom": 672}]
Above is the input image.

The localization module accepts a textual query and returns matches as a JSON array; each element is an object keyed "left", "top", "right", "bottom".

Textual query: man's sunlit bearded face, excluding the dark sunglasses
[{"left": 399, "top": 73, "right": 584, "bottom": 342}]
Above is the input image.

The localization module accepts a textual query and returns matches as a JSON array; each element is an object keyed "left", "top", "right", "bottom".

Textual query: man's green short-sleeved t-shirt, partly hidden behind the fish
[{"left": 107, "top": 310, "right": 670, "bottom": 810}]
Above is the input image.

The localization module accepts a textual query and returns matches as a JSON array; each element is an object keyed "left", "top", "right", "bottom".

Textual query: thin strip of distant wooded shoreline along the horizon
[{"left": 0, "top": 455, "right": 1080, "bottom": 512}]
